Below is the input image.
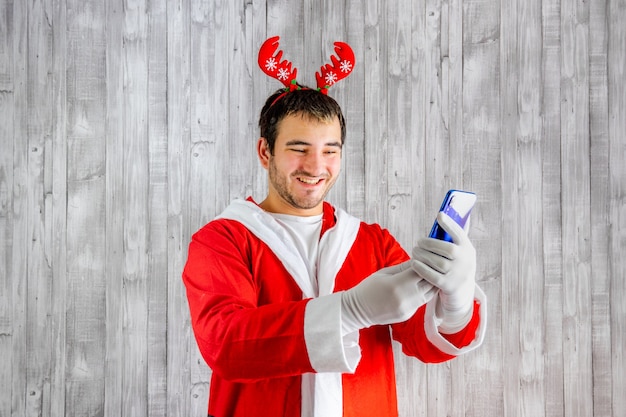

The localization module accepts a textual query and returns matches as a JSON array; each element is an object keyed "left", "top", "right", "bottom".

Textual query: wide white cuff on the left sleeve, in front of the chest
[{"left": 304, "top": 293, "right": 361, "bottom": 373}]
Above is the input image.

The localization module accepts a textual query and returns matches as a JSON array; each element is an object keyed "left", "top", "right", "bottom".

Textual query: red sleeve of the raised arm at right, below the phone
[{"left": 392, "top": 301, "right": 480, "bottom": 363}]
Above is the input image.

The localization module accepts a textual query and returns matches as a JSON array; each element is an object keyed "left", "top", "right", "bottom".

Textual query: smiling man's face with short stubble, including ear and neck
[{"left": 257, "top": 115, "right": 342, "bottom": 216}]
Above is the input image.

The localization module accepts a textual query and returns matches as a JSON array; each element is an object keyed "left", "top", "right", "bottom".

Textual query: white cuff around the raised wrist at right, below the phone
[{"left": 424, "top": 285, "right": 487, "bottom": 356}]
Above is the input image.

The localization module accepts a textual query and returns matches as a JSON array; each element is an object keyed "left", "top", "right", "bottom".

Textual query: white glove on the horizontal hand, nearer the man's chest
[{"left": 341, "top": 261, "right": 437, "bottom": 335}]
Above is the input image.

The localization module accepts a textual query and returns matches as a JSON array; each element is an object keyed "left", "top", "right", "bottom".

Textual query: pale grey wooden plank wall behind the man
[{"left": 0, "top": 0, "right": 626, "bottom": 417}]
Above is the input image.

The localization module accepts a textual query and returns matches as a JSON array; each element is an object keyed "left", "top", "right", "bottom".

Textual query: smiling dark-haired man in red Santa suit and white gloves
[{"left": 183, "top": 88, "right": 486, "bottom": 417}]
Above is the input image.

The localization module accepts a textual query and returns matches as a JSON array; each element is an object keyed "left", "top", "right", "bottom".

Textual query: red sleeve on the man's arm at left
[{"left": 183, "top": 220, "right": 313, "bottom": 381}]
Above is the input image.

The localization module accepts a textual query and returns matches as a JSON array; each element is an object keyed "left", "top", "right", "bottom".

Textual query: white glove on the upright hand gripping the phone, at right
[{"left": 412, "top": 212, "right": 476, "bottom": 333}]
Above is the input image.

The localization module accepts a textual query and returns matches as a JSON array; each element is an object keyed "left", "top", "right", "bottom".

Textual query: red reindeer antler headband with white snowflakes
[{"left": 259, "top": 36, "right": 354, "bottom": 99}]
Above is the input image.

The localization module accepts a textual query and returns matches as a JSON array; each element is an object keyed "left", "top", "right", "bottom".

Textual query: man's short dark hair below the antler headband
[{"left": 259, "top": 86, "right": 346, "bottom": 154}]
